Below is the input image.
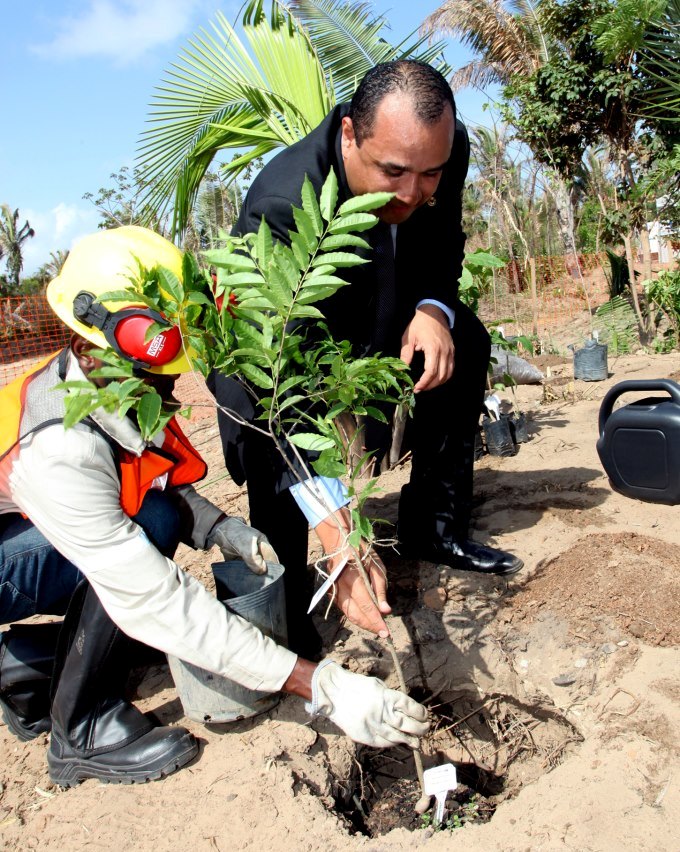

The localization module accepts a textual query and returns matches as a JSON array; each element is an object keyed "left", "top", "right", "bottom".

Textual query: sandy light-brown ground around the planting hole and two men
[{"left": 0, "top": 342, "right": 680, "bottom": 852}]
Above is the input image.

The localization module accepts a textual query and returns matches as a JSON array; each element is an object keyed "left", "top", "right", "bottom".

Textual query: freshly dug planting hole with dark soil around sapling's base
[{"left": 328, "top": 694, "right": 581, "bottom": 837}]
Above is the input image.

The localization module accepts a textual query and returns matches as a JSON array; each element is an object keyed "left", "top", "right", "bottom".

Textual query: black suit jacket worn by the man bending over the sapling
[{"left": 233, "top": 104, "right": 470, "bottom": 355}]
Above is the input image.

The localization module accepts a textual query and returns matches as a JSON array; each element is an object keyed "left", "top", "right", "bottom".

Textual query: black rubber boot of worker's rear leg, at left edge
[{"left": 0, "top": 621, "right": 61, "bottom": 740}]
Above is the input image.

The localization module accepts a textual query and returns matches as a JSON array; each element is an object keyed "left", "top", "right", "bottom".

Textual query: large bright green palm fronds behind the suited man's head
[{"left": 138, "top": 0, "right": 445, "bottom": 234}]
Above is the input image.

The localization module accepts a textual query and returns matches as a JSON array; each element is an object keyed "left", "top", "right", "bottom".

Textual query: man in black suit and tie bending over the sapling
[{"left": 213, "top": 60, "right": 523, "bottom": 656}]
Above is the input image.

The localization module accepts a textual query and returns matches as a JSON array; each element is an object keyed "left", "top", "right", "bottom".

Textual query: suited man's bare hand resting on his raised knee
[{"left": 400, "top": 305, "right": 455, "bottom": 393}]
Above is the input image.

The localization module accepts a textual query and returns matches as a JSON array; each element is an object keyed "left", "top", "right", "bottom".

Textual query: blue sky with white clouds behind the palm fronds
[{"left": 0, "top": 0, "right": 486, "bottom": 275}]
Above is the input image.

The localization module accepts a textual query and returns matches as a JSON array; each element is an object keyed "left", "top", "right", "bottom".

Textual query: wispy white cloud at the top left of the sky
[{"left": 34, "top": 0, "right": 203, "bottom": 65}]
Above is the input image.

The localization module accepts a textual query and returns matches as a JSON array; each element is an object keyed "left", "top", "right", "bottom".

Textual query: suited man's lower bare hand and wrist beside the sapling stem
[{"left": 315, "top": 509, "right": 392, "bottom": 639}]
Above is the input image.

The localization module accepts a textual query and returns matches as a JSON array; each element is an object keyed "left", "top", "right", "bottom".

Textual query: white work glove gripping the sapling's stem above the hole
[{"left": 305, "top": 660, "right": 430, "bottom": 748}]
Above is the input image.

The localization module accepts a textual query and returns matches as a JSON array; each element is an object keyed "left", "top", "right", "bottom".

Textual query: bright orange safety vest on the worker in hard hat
[{"left": 0, "top": 355, "right": 208, "bottom": 517}]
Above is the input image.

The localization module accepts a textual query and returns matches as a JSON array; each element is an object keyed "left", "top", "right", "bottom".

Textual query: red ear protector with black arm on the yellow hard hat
[{"left": 73, "top": 290, "right": 182, "bottom": 370}]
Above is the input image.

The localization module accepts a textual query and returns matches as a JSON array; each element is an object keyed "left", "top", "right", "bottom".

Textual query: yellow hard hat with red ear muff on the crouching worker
[{"left": 47, "top": 225, "right": 193, "bottom": 374}]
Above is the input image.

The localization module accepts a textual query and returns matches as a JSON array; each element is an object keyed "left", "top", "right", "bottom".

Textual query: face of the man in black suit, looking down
[{"left": 342, "top": 93, "right": 455, "bottom": 225}]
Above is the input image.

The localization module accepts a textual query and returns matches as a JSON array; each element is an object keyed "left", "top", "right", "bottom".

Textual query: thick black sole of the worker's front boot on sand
[{"left": 47, "top": 733, "right": 198, "bottom": 787}]
